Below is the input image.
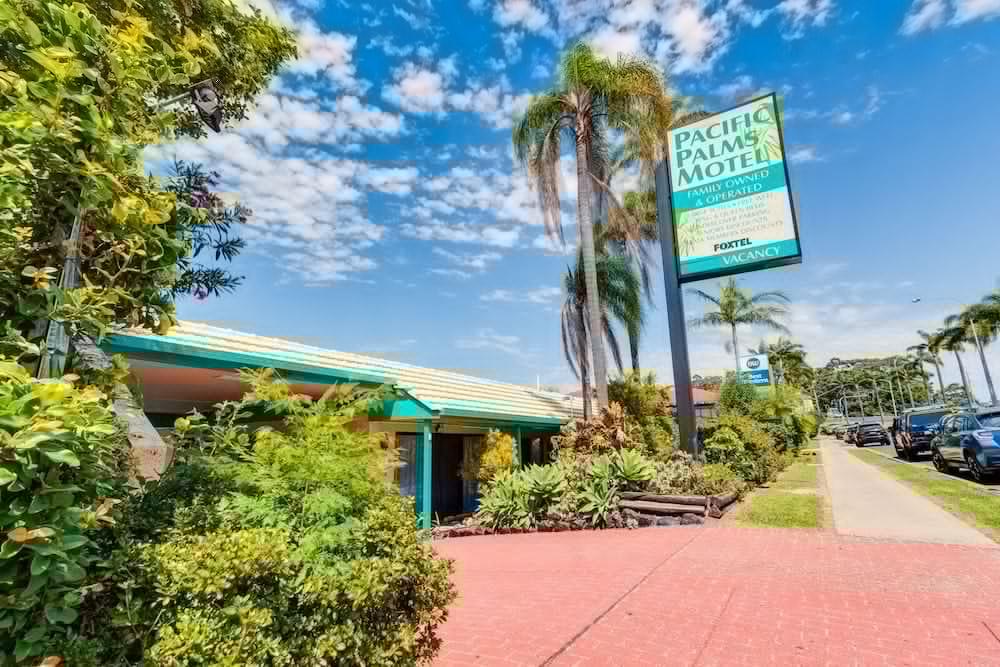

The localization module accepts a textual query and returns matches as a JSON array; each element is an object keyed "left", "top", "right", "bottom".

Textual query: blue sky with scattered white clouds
[{"left": 154, "top": 0, "right": 1000, "bottom": 393}]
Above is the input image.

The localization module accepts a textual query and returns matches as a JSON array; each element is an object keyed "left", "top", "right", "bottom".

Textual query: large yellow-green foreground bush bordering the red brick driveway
[{"left": 67, "top": 373, "right": 455, "bottom": 667}]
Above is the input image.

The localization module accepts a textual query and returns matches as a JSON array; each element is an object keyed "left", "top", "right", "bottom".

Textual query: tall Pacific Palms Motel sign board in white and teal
[{"left": 670, "top": 94, "right": 802, "bottom": 283}]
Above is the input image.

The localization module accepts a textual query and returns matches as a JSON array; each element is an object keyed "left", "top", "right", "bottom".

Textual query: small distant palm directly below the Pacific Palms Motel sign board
[{"left": 688, "top": 278, "right": 790, "bottom": 381}]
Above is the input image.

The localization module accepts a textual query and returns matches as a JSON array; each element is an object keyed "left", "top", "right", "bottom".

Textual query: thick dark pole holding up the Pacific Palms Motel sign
[{"left": 655, "top": 150, "right": 700, "bottom": 459}]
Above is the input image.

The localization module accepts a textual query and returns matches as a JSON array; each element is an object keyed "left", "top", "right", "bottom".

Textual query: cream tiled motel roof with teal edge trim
[{"left": 106, "top": 322, "right": 583, "bottom": 422}]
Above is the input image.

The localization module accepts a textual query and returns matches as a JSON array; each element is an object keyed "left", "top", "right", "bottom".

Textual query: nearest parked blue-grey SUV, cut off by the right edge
[{"left": 931, "top": 408, "right": 1000, "bottom": 482}]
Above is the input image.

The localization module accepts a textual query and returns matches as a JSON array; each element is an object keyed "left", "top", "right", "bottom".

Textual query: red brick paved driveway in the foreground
[{"left": 435, "top": 527, "right": 1000, "bottom": 667}]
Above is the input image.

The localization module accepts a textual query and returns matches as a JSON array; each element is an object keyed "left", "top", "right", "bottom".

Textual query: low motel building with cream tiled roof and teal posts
[{"left": 101, "top": 322, "right": 583, "bottom": 527}]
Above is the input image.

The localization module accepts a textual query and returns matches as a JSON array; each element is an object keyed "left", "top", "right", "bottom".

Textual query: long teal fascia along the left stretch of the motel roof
[{"left": 101, "top": 334, "right": 391, "bottom": 384}]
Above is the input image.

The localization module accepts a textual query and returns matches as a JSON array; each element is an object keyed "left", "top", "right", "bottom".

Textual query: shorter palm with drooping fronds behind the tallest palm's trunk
[{"left": 561, "top": 251, "right": 642, "bottom": 419}]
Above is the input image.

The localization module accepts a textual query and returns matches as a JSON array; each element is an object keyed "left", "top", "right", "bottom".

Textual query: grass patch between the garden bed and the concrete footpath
[{"left": 736, "top": 455, "right": 823, "bottom": 528}]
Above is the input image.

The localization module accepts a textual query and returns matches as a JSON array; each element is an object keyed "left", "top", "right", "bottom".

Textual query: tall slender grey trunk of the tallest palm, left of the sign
[{"left": 576, "top": 134, "right": 608, "bottom": 408}]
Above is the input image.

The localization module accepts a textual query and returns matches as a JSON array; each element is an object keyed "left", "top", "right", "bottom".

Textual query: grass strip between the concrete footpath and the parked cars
[{"left": 851, "top": 450, "right": 1000, "bottom": 538}]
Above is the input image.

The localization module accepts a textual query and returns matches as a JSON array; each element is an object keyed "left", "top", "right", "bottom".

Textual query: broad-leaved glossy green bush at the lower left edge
[{"left": 0, "top": 360, "right": 128, "bottom": 665}]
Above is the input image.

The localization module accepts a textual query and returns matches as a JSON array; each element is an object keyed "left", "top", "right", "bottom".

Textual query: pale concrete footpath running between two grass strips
[{"left": 820, "top": 438, "right": 995, "bottom": 546}]
